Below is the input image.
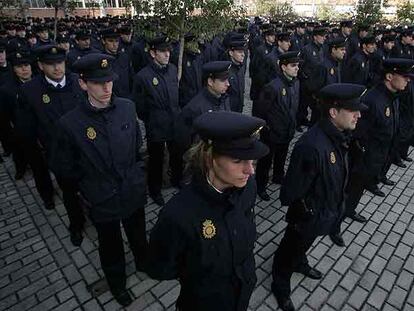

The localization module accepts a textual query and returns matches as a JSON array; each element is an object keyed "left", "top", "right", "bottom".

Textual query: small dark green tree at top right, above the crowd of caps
[{"left": 356, "top": 0, "right": 387, "bottom": 25}]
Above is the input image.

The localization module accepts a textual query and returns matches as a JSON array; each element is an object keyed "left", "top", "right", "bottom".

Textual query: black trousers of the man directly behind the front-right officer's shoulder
[{"left": 256, "top": 140, "right": 289, "bottom": 192}]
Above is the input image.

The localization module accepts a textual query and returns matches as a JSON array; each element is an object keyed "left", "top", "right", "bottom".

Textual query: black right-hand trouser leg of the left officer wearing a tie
[{"left": 55, "top": 175, "right": 85, "bottom": 231}]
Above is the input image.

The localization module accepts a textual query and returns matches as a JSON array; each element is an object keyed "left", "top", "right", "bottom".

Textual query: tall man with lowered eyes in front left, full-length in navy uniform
[{"left": 58, "top": 53, "right": 147, "bottom": 306}]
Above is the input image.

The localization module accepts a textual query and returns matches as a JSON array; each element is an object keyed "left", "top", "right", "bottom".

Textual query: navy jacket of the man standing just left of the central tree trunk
[{"left": 133, "top": 62, "right": 180, "bottom": 142}]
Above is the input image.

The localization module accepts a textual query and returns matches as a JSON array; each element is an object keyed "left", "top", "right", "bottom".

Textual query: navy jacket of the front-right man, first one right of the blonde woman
[{"left": 280, "top": 119, "right": 348, "bottom": 236}]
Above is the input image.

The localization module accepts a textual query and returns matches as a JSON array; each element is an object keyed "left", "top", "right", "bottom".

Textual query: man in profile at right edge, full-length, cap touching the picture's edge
[{"left": 346, "top": 58, "right": 414, "bottom": 222}]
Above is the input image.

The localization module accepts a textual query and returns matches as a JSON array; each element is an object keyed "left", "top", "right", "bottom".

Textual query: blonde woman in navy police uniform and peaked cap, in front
[{"left": 147, "top": 111, "right": 268, "bottom": 311}]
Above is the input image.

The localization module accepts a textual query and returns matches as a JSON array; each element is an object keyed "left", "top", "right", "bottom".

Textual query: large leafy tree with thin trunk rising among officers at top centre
[{"left": 132, "top": 0, "right": 242, "bottom": 79}]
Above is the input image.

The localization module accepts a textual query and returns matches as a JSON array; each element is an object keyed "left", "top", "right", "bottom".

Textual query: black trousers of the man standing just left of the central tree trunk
[{"left": 147, "top": 141, "right": 183, "bottom": 195}]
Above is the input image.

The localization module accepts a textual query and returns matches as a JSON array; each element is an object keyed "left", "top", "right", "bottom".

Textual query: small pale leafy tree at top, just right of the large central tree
[{"left": 257, "top": 0, "right": 298, "bottom": 21}]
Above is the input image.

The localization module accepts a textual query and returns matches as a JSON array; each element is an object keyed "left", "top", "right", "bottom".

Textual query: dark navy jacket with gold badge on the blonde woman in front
[{"left": 148, "top": 176, "right": 256, "bottom": 311}]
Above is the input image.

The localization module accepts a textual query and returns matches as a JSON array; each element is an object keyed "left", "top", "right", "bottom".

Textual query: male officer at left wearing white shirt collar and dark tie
[{"left": 16, "top": 44, "right": 85, "bottom": 246}]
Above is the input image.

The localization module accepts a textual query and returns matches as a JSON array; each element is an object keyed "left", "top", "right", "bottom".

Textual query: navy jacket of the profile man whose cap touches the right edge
[{"left": 353, "top": 83, "right": 399, "bottom": 177}]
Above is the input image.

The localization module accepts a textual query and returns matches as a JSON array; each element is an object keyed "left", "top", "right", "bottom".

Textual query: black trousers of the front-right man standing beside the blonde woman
[{"left": 272, "top": 225, "right": 316, "bottom": 297}]
